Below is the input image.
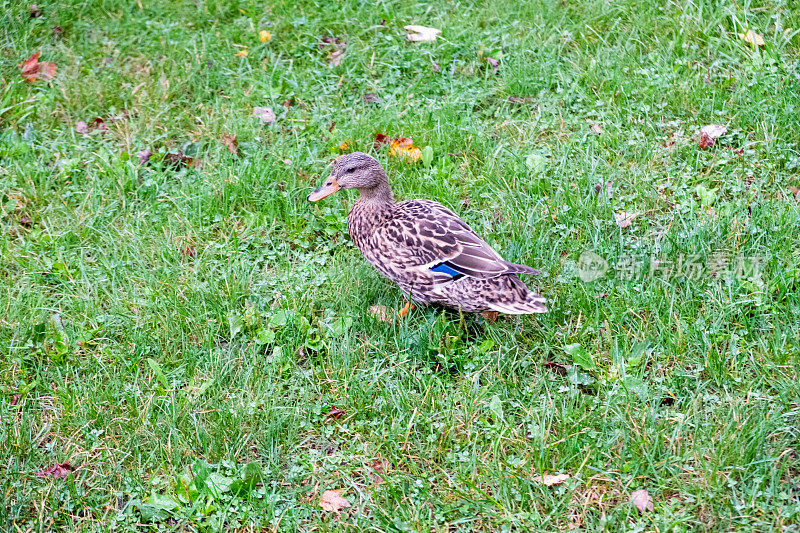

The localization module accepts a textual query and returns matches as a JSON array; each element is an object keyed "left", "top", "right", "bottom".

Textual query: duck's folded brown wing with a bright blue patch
[{"left": 382, "top": 200, "right": 539, "bottom": 282}]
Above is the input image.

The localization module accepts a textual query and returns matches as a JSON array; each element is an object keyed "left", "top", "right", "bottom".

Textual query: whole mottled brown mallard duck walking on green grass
[{"left": 308, "top": 152, "right": 547, "bottom": 315}]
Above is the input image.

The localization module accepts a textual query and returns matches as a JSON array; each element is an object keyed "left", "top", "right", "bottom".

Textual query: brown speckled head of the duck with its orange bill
[{"left": 308, "top": 152, "right": 388, "bottom": 202}]
